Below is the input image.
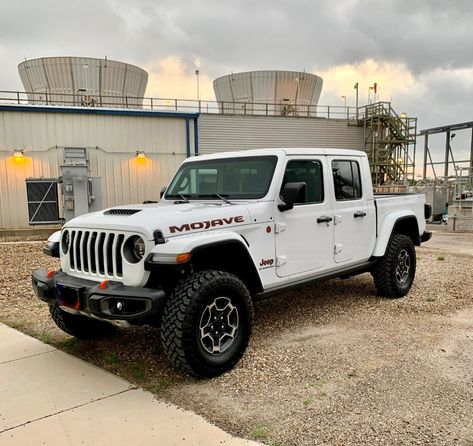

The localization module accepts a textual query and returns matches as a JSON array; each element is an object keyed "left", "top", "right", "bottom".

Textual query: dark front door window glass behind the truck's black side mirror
[{"left": 283, "top": 160, "right": 324, "bottom": 203}]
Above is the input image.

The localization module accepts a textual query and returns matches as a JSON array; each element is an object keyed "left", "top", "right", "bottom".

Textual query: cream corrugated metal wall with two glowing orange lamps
[{"left": 0, "top": 106, "right": 194, "bottom": 229}]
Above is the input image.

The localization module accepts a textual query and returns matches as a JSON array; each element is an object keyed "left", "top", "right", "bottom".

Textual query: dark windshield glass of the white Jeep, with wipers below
[{"left": 165, "top": 156, "right": 277, "bottom": 200}]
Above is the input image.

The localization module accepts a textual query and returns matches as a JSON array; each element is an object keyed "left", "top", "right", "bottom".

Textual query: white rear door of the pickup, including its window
[{"left": 329, "top": 157, "right": 376, "bottom": 263}]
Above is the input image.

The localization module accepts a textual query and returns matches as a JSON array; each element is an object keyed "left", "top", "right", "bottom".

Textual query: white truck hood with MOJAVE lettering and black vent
[{"left": 64, "top": 202, "right": 254, "bottom": 240}]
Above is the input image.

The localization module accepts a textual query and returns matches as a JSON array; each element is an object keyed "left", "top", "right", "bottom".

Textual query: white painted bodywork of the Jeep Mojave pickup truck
[{"left": 56, "top": 149, "right": 425, "bottom": 291}]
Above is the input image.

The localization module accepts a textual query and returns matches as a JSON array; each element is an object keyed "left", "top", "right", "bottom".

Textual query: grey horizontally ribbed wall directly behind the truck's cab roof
[{"left": 199, "top": 114, "right": 365, "bottom": 153}]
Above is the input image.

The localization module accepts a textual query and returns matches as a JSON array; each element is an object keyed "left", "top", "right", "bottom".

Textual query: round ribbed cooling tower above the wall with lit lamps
[{"left": 18, "top": 57, "right": 148, "bottom": 108}]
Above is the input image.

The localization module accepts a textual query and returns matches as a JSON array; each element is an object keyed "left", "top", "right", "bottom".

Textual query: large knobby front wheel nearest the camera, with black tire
[{"left": 161, "top": 270, "right": 254, "bottom": 378}]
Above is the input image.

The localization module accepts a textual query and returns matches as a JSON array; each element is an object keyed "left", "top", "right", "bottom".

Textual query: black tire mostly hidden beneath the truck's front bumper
[{"left": 49, "top": 303, "right": 116, "bottom": 340}]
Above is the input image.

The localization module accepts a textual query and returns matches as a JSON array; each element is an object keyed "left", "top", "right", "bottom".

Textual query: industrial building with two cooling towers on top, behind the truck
[{"left": 0, "top": 58, "right": 416, "bottom": 229}]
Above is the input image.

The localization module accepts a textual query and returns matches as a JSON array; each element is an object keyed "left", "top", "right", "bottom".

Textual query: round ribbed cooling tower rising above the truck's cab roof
[{"left": 213, "top": 70, "right": 323, "bottom": 116}]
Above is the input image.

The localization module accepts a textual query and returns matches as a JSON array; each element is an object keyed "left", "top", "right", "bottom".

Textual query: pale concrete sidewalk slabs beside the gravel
[{"left": 0, "top": 323, "right": 258, "bottom": 446}]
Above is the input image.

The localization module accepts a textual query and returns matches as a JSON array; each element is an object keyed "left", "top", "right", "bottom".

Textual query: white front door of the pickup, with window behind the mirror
[{"left": 275, "top": 156, "right": 333, "bottom": 277}]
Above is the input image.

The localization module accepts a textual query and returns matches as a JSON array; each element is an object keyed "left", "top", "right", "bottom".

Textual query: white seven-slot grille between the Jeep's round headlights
[{"left": 68, "top": 229, "right": 125, "bottom": 278}]
